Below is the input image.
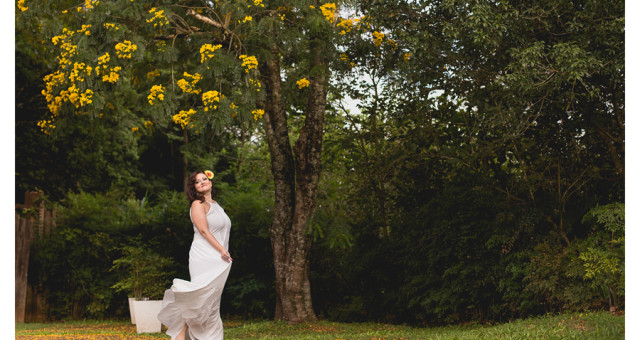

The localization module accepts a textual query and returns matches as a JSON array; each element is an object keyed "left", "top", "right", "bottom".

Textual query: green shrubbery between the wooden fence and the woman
[{"left": 29, "top": 192, "right": 186, "bottom": 319}]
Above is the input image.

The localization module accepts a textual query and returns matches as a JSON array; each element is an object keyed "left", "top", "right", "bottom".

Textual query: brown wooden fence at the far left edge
[{"left": 15, "top": 191, "right": 56, "bottom": 322}]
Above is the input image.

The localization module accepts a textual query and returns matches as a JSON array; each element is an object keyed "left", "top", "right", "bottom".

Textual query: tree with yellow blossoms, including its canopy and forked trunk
[{"left": 20, "top": 0, "right": 370, "bottom": 322}]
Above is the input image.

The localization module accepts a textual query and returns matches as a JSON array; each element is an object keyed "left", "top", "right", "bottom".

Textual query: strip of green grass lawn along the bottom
[{"left": 15, "top": 312, "right": 625, "bottom": 340}]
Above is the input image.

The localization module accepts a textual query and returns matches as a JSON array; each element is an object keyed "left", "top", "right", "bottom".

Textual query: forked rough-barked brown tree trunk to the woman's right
[{"left": 260, "top": 41, "right": 329, "bottom": 323}]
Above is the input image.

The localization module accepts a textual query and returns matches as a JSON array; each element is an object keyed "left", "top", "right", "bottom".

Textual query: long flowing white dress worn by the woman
[{"left": 158, "top": 203, "right": 231, "bottom": 340}]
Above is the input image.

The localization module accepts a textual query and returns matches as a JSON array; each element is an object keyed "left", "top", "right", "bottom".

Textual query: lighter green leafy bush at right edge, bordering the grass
[{"left": 525, "top": 203, "right": 624, "bottom": 312}]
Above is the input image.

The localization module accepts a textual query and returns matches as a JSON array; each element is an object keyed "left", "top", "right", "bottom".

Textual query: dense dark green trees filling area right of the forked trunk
[{"left": 312, "top": 0, "right": 624, "bottom": 323}]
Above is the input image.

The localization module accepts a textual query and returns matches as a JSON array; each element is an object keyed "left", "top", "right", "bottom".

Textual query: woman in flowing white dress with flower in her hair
[{"left": 158, "top": 170, "right": 233, "bottom": 340}]
